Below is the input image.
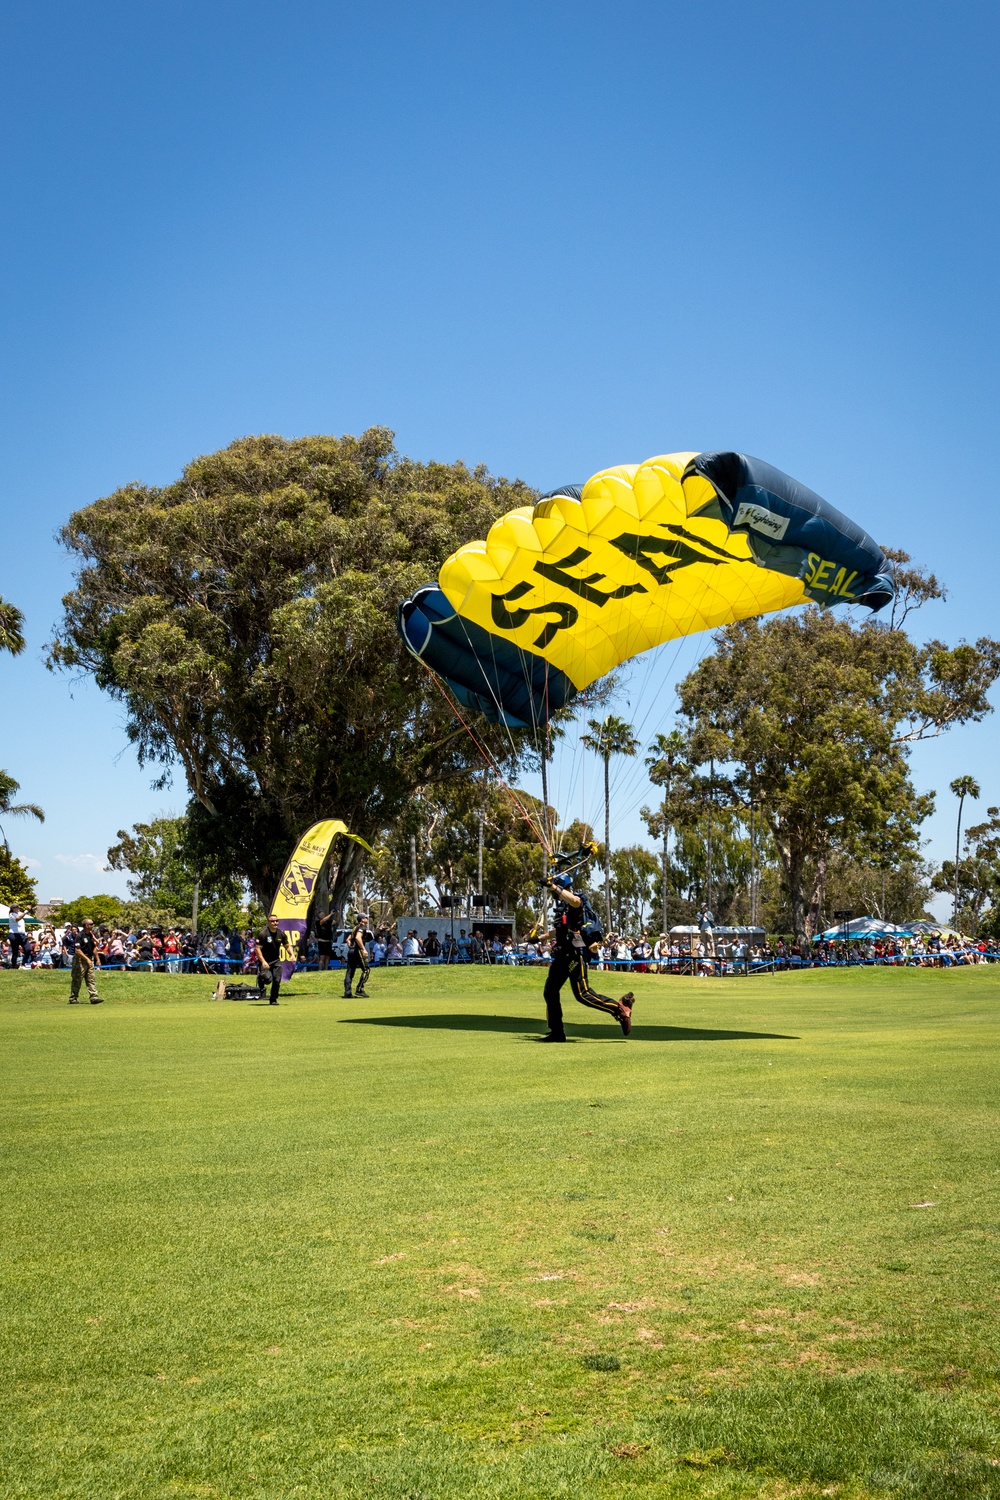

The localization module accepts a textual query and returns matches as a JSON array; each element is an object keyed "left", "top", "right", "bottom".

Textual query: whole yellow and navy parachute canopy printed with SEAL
[{"left": 399, "top": 453, "right": 892, "bottom": 729}]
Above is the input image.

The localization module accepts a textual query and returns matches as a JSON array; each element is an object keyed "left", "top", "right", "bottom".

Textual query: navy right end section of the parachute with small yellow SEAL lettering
[{"left": 684, "top": 453, "right": 894, "bottom": 611}]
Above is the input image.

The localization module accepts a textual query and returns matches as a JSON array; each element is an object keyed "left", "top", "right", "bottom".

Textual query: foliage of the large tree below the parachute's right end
[{"left": 678, "top": 609, "right": 1000, "bottom": 942}]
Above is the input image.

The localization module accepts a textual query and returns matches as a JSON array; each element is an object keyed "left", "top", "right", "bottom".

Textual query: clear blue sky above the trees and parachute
[{"left": 0, "top": 0, "right": 1000, "bottom": 899}]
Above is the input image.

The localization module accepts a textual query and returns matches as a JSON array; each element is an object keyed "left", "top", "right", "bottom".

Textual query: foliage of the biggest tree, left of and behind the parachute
[{"left": 49, "top": 428, "right": 534, "bottom": 909}]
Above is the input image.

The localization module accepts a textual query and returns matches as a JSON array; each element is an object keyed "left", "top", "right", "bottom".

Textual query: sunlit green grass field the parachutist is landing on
[{"left": 0, "top": 968, "right": 1000, "bottom": 1500}]
